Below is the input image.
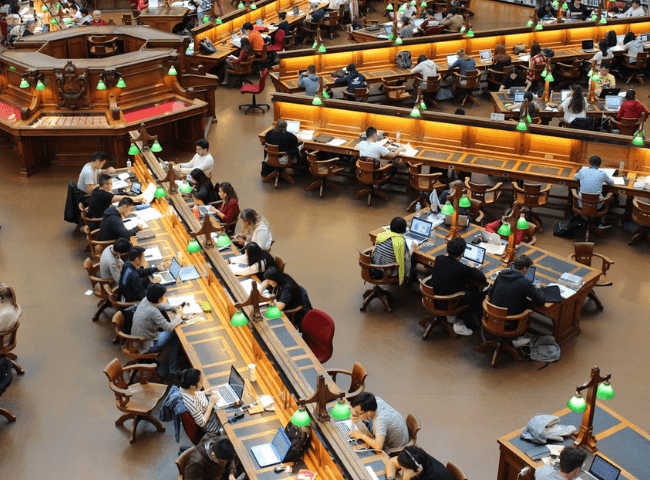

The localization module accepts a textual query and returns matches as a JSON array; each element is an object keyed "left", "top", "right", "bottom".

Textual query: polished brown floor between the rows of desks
[{"left": 0, "top": 1, "right": 650, "bottom": 480}]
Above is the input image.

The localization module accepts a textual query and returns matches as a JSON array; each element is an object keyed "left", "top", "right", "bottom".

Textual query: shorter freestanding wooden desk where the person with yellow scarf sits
[{"left": 370, "top": 209, "right": 601, "bottom": 344}]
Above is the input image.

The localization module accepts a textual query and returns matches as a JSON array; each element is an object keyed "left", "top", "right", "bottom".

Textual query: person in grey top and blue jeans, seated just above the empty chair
[{"left": 131, "top": 284, "right": 183, "bottom": 377}]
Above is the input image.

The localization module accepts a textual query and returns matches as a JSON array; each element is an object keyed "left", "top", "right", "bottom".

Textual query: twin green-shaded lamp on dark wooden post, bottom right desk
[{"left": 567, "top": 366, "right": 614, "bottom": 452}]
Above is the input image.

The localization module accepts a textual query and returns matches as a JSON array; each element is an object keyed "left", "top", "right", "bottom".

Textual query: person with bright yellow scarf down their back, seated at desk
[{"left": 372, "top": 217, "right": 413, "bottom": 285}]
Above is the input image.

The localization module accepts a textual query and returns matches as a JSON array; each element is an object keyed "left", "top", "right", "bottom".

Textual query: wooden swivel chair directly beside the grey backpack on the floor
[{"left": 476, "top": 298, "right": 533, "bottom": 367}]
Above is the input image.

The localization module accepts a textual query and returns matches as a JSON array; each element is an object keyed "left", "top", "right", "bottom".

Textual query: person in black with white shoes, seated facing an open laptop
[{"left": 427, "top": 237, "right": 486, "bottom": 335}]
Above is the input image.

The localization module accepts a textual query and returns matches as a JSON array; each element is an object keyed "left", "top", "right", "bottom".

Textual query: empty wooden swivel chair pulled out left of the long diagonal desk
[{"left": 104, "top": 358, "right": 171, "bottom": 443}]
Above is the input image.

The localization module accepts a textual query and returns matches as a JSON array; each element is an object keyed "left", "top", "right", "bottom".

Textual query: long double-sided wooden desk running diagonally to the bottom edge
[{"left": 128, "top": 145, "right": 385, "bottom": 480}]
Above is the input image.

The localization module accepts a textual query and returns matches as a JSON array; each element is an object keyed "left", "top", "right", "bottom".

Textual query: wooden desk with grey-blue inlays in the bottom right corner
[{"left": 497, "top": 402, "right": 650, "bottom": 480}]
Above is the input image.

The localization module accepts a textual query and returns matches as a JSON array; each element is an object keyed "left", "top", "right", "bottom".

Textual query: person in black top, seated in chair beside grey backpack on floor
[{"left": 488, "top": 255, "right": 544, "bottom": 315}]
